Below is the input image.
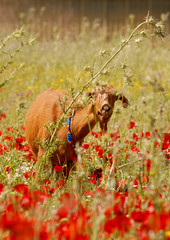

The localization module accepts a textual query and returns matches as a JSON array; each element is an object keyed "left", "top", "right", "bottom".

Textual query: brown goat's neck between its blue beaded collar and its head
[{"left": 72, "top": 103, "right": 97, "bottom": 141}]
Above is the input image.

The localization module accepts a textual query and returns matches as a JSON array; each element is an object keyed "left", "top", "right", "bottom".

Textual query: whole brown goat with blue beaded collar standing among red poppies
[{"left": 25, "top": 85, "right": 128, "bottom": 170}]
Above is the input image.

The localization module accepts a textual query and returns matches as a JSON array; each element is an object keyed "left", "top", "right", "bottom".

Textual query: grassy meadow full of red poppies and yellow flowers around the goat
[{"left": 0, "top": 17, "right": 170, "bottom": 240}]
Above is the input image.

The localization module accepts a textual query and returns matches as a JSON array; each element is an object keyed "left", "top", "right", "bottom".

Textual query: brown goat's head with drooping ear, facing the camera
[{"left": 90, "top": 85, "right": 128, "bottom": 132}]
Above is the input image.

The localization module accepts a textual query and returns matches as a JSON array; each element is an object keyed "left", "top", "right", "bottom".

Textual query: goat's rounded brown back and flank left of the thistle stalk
[{"left": 25, "top": 89, "right": 70, "bottom": 157}]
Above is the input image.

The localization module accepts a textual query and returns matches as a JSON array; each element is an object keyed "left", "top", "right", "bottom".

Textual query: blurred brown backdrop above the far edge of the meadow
[{"left": 0, "top": 0, "right": 170, "bottom": 41}]
